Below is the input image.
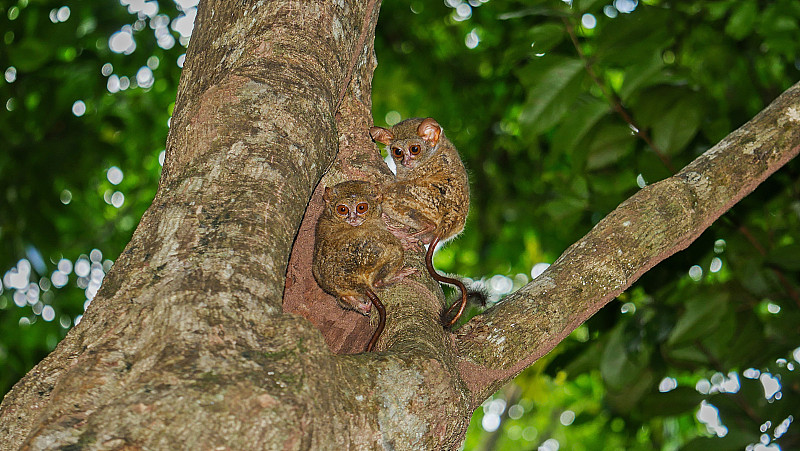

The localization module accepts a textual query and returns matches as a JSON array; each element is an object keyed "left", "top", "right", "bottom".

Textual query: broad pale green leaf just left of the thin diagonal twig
[{"left": 518, "top": 55, "right": 584, "bottom": 133}]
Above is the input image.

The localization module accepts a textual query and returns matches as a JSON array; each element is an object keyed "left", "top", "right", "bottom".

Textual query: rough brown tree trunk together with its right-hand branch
[{"left": 0, "top": 0, "right": 800, "bottom": 449}]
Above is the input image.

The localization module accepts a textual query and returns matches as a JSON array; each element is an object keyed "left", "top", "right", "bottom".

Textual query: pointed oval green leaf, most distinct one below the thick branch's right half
[{"left": 667, "top": 292, "right": 729, "bottom": 346}]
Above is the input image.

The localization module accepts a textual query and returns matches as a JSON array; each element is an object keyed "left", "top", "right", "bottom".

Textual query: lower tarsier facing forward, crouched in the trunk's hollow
[{"left": 312, "top": 181, "right": 416, "bottom": 351}]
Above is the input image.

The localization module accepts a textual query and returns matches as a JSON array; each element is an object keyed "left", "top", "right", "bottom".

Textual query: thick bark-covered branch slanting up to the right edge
[{"left": 458, "top": 79, "right": 800, "bottom": 403}]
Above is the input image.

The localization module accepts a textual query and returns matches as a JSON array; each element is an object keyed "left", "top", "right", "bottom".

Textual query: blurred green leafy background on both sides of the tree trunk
[{"left": 0, "top": 0, "right": 800, "bottom": 450}]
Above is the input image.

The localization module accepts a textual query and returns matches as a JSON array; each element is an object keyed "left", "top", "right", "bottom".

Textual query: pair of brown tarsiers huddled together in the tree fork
[{"left": 312, "top": 118, "right": 469, "bottom": 351}]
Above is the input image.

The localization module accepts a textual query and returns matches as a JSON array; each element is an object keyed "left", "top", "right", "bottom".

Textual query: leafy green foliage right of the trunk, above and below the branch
[{"left": 373, "top": 0, "right": 800, "bottom": 449}]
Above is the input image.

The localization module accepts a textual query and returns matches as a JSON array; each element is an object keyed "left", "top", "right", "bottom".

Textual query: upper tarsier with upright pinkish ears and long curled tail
[{"left": 369, "top": 117, "right": 469, "bottom": 327}]
